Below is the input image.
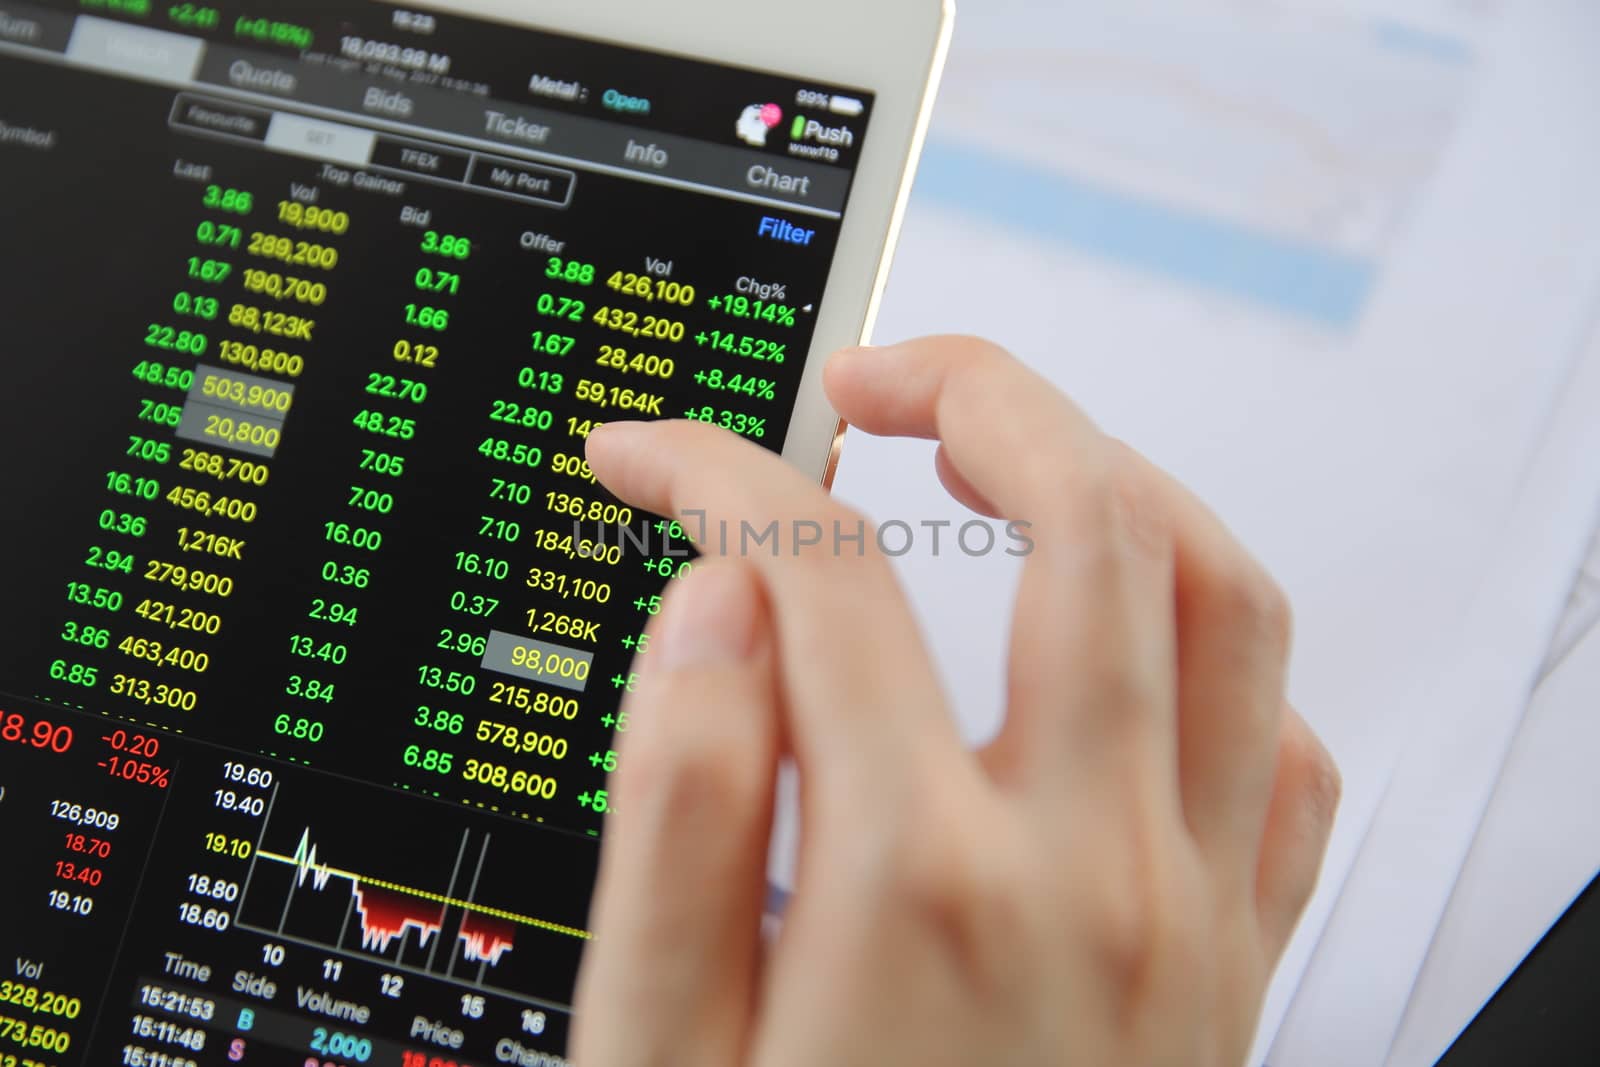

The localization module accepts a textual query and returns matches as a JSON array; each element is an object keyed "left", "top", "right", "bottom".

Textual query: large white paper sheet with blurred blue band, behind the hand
[{"left": 837, "top": 0, "right": 1600, "bottom": 1067}]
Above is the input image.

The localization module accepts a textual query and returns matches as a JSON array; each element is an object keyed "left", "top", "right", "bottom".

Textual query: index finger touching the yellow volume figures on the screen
[{"left": 589, "top": 422, "right": 962, "bottom": 803}]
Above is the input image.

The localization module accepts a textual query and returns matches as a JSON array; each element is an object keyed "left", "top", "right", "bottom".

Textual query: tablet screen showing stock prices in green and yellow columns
[{"left": 0, "top": 0, "right": 872, "bottom": 1067}]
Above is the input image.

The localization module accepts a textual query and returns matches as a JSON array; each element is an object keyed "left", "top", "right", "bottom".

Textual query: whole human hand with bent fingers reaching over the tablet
[{"left": 573, "top": 338, "right": 1339, "bottom": 1067}]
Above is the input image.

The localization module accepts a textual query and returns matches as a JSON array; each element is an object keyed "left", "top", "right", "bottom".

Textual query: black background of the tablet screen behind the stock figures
[{"left": 0, "top": 4, "right": 870, "bottom": 1065}]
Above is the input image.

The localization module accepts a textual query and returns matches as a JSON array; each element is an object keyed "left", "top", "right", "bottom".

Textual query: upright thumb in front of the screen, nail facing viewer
[{"left": 573, "top": 561, "right": 779, "bottom": 1067}]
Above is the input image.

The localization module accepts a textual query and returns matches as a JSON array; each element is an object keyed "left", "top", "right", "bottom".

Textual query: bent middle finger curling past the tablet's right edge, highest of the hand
[{"left": 827, "top": 338, "right": 1178, "bottom": 799}]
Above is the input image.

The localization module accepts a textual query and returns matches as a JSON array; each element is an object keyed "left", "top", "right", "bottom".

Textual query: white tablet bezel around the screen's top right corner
[{"left": 395, "top": 0, "right": 955, "bottom": 485}]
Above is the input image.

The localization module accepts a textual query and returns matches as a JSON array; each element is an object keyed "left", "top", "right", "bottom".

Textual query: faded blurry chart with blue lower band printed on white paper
[{"left": 918, "top": 2, "right": 1477, "bottom": 328}]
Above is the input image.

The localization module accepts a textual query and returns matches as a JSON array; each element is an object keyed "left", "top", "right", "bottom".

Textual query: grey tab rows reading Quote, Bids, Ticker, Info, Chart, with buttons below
[{"left": 18, "top": 20, "right": 851, "bottom": 218}]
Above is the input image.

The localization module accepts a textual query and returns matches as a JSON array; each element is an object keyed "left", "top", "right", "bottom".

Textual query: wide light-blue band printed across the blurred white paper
[{"left": 917, "top": 141, "right": 1378, "bottom": 330}]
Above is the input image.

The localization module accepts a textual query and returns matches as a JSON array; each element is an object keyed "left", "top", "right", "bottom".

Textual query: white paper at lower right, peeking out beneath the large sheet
[{"left": 1270, "top": 313, "right": 1600, "bottom": 1067}]
